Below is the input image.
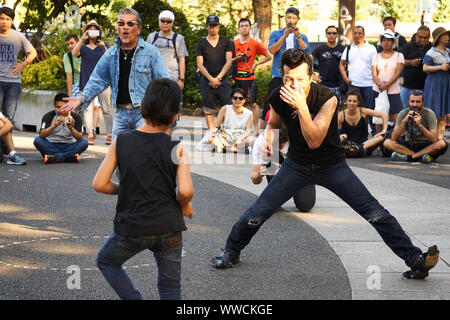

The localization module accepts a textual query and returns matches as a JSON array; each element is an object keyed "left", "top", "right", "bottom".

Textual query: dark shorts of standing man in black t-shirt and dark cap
[{"left": 200, "top": 76, "right": 231, "bottom": 114}]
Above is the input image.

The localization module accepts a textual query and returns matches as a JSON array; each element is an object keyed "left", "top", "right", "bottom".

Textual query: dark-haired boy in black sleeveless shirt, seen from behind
[{"left": 92, "top": 79, "right": 194, "bottom": 300}]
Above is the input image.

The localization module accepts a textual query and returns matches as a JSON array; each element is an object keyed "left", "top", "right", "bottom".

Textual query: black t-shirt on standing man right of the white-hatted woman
[{"left": 402, "top": 42, "right": 431, "bottom": 90}]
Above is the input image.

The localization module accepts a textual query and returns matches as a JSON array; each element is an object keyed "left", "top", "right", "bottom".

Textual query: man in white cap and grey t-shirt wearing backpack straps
[{"left": 147, "top": 10, "right": 188, "bottom": 134}]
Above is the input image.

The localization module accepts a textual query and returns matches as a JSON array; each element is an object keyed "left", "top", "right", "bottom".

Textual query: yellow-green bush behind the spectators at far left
[{"left": 22, "top": 47, "right": 66, "bottom": 90}]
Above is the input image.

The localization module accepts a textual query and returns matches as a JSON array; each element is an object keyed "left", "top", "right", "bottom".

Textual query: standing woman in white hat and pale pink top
[{"left": 369, "top": 30, "right": 405, "bottom": 132}]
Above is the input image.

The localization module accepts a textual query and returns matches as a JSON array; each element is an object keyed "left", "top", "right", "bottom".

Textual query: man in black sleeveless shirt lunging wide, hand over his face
[{"left": 212, "top": 49, "right": 439, "bottom": 279}]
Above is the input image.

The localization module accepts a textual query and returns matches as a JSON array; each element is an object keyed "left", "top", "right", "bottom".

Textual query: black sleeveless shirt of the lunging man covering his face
[{"left": 269, "top": 83, "right": 345, "bottom": 165}]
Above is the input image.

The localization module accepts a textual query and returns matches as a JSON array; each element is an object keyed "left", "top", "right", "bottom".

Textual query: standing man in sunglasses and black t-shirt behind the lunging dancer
[{"left": 311, "top": 26, "right": 345, "bottom": 106}]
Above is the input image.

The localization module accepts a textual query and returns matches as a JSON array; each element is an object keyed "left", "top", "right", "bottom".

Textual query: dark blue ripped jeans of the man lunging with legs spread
[{"left": 225, "top": 157, "right": 422, "bottom": 267}]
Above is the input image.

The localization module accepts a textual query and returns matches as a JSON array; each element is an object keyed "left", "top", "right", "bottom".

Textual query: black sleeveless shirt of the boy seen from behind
[{"left": 114, "top": 130, "right": 186, "bottom": 237}]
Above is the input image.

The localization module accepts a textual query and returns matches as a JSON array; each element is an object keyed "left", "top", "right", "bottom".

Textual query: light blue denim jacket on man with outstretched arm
[{"left": 77, "top": 37, "right": 169, "bottom": 111}]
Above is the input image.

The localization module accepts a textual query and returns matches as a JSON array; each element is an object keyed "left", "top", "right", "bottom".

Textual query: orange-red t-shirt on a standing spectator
[{"left": 234, "top": 38, "right": 267, "bottom": 80}]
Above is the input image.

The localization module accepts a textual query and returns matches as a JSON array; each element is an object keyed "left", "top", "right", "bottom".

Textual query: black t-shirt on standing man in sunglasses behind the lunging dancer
[{"left": 312, "top": 44, "right": 345, "bottom": 87}]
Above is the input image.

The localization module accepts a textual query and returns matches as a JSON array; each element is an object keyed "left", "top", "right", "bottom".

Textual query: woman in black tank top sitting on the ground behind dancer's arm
[{"left": 338, "top": 89, "right": 388, "bottom": 158}]
